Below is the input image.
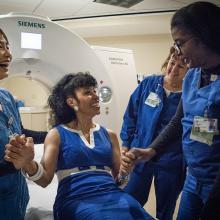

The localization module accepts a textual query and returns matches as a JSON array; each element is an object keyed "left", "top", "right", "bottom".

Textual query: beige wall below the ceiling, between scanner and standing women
[{"left": 84, "top": 34, "right": 172, "bottom": 74}]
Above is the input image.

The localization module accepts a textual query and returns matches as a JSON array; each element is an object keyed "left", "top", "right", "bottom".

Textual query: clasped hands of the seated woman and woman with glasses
[{"left": 120, "top": 147, "right": 156, "bottom": 176}]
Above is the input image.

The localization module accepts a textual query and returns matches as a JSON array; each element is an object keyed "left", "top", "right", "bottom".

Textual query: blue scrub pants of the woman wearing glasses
[{"left": 177, "top": 174, "right": 214, "bottom": 220}]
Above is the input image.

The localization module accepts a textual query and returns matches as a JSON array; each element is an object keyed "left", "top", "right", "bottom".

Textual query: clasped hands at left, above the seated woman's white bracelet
[{"left": 4, "top": 135, "right": 34, "bottom": 169}]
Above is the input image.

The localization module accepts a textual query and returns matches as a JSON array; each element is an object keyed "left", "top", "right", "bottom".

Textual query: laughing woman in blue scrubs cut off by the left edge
[{"left": 0, "top": 29, "right": 46, "bottom": 220}]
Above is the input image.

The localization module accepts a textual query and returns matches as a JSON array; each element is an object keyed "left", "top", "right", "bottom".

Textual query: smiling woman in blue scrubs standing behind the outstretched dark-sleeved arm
[{"left": 121, "top": 47, "right": 188, "bottom": 220}]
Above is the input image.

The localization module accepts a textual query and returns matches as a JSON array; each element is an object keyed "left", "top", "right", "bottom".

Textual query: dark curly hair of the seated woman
[{"left": 48, "top": 72, "right": 97, "bottom": 125}]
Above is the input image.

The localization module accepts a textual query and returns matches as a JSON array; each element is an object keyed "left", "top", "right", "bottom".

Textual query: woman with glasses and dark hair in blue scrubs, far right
[{"left": 123, "top": 2, "right": 220, "bottom": 220}]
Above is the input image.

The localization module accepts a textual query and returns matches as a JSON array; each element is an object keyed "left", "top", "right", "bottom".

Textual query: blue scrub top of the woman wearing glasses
[{"left": 182, "top": 68, "right": 220, "bottom": 184}]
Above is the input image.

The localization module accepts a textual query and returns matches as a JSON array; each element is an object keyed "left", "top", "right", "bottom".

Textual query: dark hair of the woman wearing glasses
[{"left": 171, "top": 1, "right": 220, "bottom": 54}]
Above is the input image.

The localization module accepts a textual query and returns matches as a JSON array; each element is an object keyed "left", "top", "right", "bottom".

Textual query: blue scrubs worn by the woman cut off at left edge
[{"left": 0, "top": 89, "right": 29, "bottom": 220}]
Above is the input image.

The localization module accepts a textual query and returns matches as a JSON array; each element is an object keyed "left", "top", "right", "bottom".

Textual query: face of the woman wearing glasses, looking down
[{"left": 171, "top": 26, "right": 207, "bottom": 68}]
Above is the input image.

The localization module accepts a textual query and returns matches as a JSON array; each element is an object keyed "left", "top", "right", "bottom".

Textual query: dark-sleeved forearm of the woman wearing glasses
[{"left": 149, "top": 100, "right": 183, "bottom": 153}]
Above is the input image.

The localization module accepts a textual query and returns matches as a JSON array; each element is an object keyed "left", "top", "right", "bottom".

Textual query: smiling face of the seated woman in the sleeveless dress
[{"left": 75, "top": 87, "right": 100, "bottom": 117}]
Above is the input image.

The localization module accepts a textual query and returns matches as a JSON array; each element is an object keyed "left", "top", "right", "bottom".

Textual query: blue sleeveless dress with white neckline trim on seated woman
[{"left": 54, "top": 125, "right": 153, "bottom": 220}]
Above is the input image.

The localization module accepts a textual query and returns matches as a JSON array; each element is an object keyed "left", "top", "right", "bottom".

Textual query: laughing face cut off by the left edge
[{"left": 0, "top": 32, "right": 12, "bottom": 80}]
